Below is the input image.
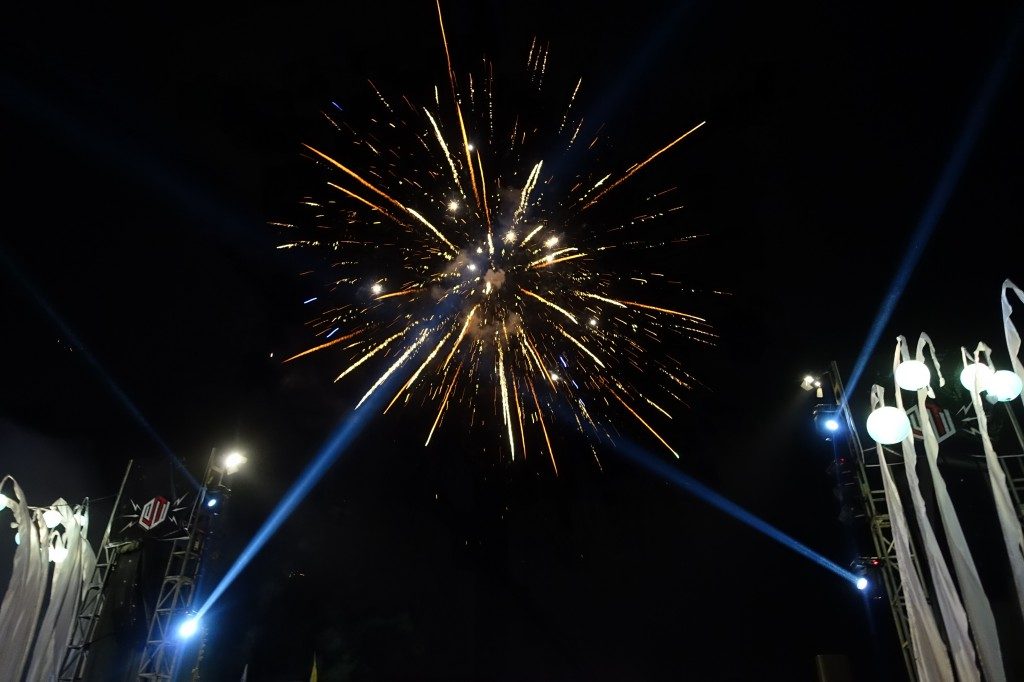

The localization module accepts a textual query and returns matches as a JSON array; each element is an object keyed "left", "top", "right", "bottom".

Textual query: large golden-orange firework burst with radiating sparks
[{"left": 275, "top": 5, "right": 716, "bottom": 473}]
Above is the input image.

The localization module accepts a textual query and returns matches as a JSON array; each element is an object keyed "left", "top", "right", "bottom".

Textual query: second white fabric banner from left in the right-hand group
[{"left": 893, "top": 334, "right": 983, "bottom": 682}]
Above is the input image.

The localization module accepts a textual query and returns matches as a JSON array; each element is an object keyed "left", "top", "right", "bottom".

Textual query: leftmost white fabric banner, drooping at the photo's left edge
[{"left": 0, "top": 476, "right": 49, "bottom": 681}]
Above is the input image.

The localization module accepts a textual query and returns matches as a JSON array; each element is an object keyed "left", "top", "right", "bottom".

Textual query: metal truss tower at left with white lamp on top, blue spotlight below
[{"left": 138, "top": 451, "right": 229, "bottom": 682}]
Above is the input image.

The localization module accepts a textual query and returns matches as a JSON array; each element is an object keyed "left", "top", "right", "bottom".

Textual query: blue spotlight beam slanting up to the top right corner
[{"left": 843, "top": 14, "right": 1024, "bottom": 407}]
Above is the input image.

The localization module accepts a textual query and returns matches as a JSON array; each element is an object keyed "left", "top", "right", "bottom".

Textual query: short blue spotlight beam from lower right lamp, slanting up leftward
[{"left": 618, "top": 440, "right": 867, "bottom": 590}]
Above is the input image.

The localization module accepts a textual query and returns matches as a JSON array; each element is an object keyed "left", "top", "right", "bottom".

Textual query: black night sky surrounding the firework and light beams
[{"left": 0, "top": 0, "right": 1024, "bottom": 680}]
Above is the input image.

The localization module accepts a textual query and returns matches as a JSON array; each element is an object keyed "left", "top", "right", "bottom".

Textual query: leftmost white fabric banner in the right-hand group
[{"left": 871, "top": 386, "right": 955, "bottom": 682}]
